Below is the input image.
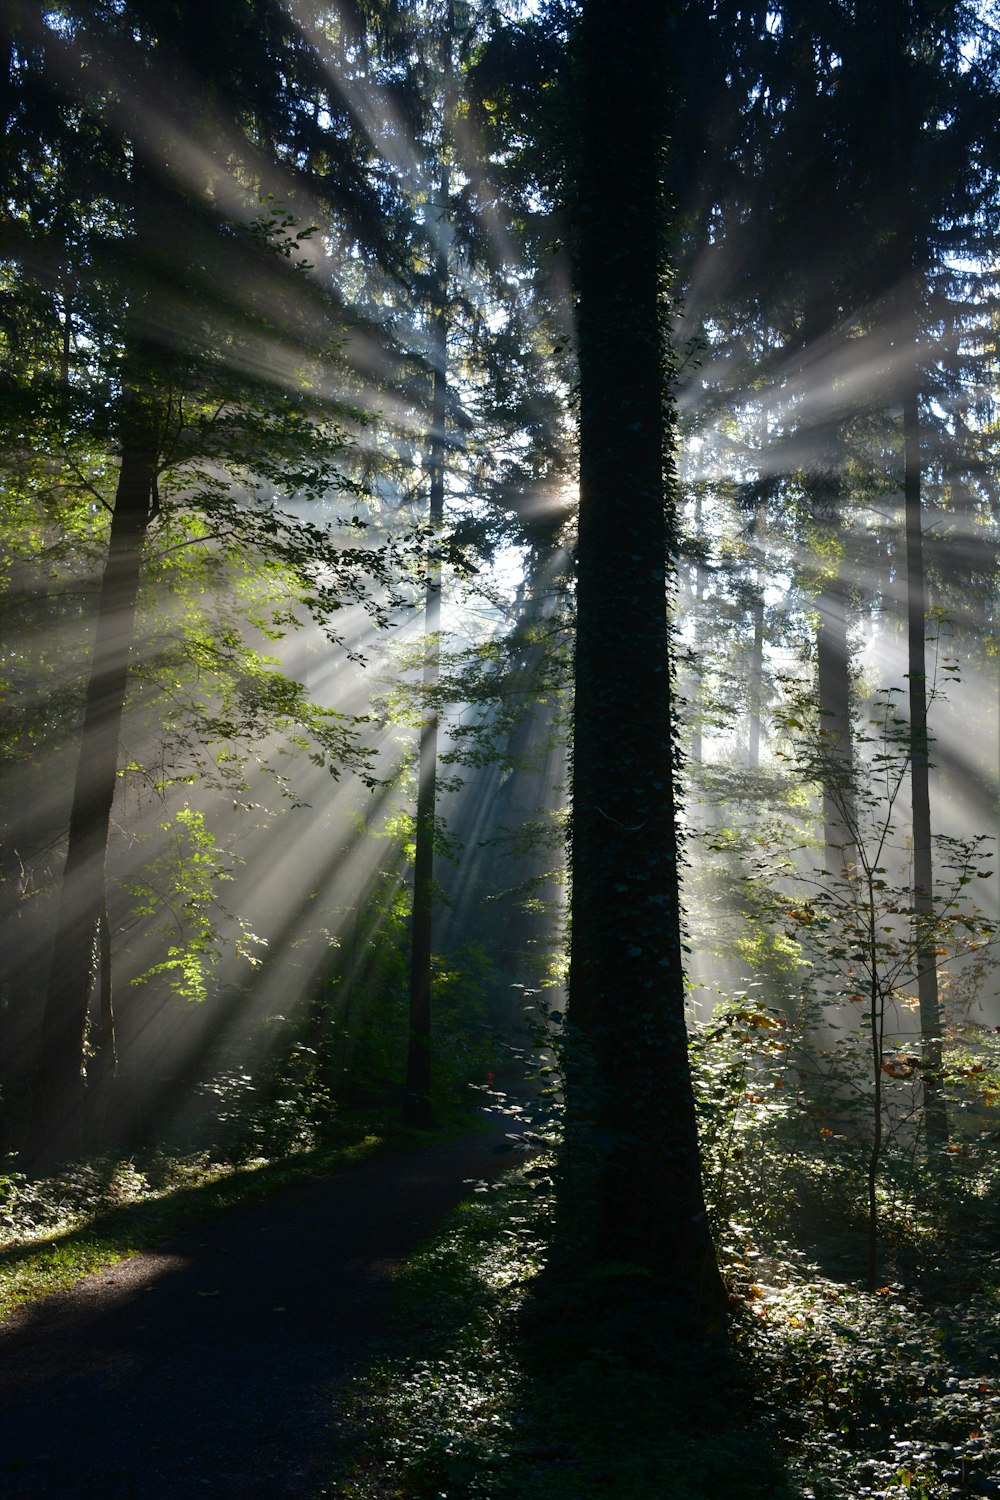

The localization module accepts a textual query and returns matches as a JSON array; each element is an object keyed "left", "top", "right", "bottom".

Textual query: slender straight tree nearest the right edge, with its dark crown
[{"left": 849, "top": 0, "right": 1000, "bottom": 1149}]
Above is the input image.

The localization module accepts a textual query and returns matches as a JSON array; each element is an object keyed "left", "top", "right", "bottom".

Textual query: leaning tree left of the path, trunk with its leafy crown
[{"left": 15, "top": 3, "right": 407, "bottom": 1164}]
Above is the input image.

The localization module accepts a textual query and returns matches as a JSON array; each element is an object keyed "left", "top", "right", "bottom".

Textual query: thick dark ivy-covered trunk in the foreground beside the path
[{"left": 564, "top": 0, "right": 721, "bottom": 1328}]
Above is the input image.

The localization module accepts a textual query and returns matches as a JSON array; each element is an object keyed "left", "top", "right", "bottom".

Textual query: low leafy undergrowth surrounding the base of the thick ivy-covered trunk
[{"left": 336, "top": 1134, "right": 1000, "bottom": 1500}]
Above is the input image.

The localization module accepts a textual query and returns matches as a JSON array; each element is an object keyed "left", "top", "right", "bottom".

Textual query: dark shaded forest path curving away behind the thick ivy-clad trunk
[{"left": 0, "top": 1116, "right": 511, "bottom": 1500}]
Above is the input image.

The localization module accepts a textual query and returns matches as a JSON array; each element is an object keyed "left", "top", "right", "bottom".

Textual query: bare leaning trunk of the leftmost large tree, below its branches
[{"left": 25, "top": 395, "right": 157, "bottom": 1169}]
